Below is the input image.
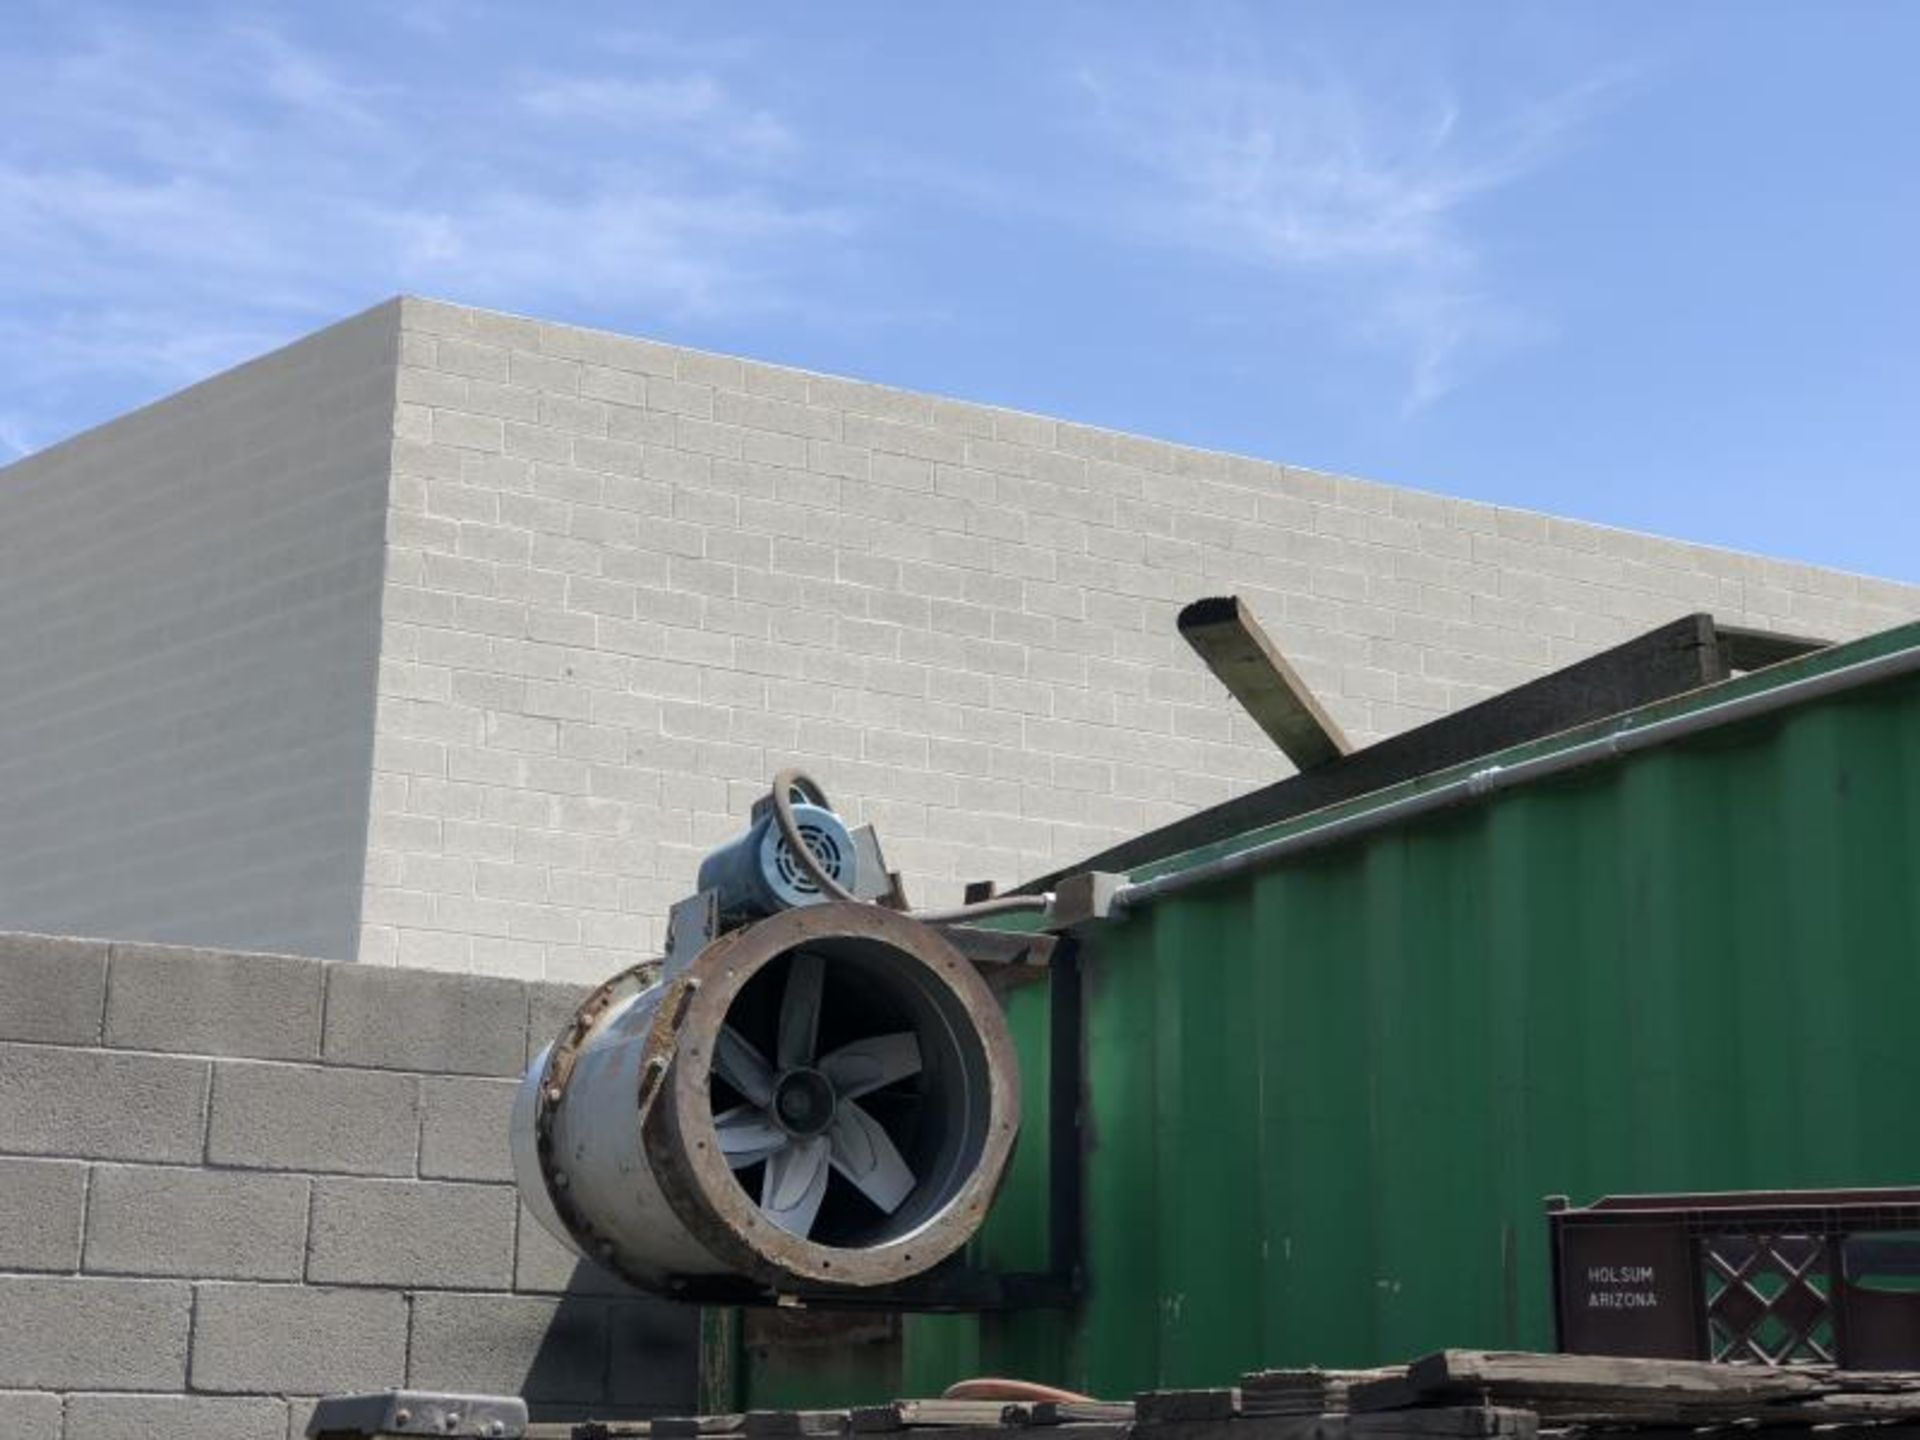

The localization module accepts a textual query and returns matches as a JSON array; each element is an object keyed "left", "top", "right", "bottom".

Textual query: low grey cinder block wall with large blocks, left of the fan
[{"left": 0, "top": 935, "right": 697, "bottom": 1440}]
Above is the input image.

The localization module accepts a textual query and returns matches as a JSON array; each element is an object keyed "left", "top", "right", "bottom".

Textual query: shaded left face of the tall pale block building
[{"left": 0, "top": 303, "right": 397, "bottom": 960}]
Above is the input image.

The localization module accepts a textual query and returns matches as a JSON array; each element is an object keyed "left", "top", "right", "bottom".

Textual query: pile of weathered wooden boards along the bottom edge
[{"left": 528, "top": 1350, "right": 1920, "bottom": 1440}]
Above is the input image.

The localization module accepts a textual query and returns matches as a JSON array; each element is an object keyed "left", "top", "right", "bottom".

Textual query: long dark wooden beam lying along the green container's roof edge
[{"left": 1020, "top": 614, "right": 1730, "bottom": 895}]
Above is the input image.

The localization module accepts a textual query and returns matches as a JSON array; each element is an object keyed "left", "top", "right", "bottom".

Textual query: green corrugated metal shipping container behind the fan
[{"left": 735, "top": 626, "right": 1920, "bottom": 1405}]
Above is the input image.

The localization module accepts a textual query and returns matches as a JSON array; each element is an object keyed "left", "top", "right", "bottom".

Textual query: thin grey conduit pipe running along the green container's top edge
[{"left": 1114, "top": 649, "right": 1920, "bottom": 910}]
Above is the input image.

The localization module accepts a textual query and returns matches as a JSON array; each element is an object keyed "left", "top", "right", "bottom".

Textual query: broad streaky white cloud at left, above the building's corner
[{"left": 0, "top": 9, "right": 840, "bottom": 453}]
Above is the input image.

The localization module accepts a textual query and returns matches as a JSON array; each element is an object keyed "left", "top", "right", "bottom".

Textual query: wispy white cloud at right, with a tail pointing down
[{"left": 1077, "top": 50, "right": 1615, "bottom": 413}]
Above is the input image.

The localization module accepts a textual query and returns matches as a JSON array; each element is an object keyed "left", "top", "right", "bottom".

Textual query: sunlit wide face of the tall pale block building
[{"left": 359, "top": 300, "right": 1920, "bottom": 979}]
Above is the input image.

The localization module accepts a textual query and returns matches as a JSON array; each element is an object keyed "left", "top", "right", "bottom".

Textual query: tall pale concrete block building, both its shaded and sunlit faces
[{"left": 0, "top": 300, "right": 1920, "bottom": 983}]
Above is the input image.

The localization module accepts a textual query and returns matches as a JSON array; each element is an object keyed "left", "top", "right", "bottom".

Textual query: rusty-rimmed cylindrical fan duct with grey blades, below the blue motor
[{"left": 513, "top": 902, "right": 1020, "bottom": 1294}]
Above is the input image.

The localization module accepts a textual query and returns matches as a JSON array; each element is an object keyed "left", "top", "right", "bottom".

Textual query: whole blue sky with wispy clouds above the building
[{"left": 0, "top": 0, "right": 1920, "bottom": 580}]
